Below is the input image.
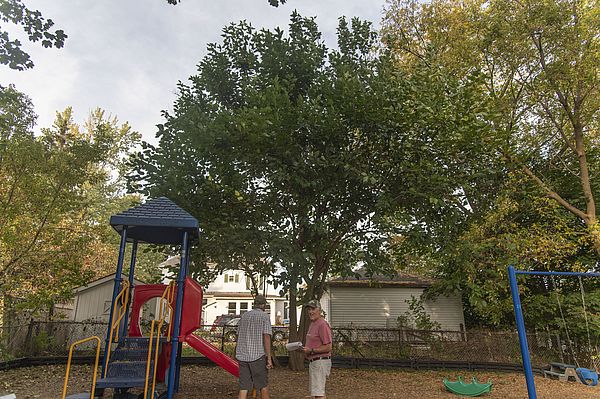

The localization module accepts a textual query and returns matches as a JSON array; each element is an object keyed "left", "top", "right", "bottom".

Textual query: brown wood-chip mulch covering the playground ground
[{"left": 0, "top": 366, "right": 600, "bottom": 399}]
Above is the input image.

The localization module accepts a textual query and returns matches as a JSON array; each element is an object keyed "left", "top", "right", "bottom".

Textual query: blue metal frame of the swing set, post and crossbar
[{"left": 508, "top": 266, "right": 600, "bottom": 399}]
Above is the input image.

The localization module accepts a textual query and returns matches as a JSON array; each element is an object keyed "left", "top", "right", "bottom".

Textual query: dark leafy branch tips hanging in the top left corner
[{"left": 0, "top": 0, "right": 67, "bottom": 71}]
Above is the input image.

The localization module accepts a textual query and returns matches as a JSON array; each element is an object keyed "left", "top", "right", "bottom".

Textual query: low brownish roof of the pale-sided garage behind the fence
[{"left": 327, "top": 269, "right": 433, "bottom": 288}]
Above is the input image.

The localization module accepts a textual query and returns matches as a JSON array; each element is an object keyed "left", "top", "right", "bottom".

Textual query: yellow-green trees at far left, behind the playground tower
[{"left": 0, "top": 87, "right": 159, "bottom": 318}]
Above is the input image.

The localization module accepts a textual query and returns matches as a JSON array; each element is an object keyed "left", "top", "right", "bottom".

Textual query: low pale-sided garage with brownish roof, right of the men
[{"left": 321, "top": 271, "right": 465, "bottom": 331}]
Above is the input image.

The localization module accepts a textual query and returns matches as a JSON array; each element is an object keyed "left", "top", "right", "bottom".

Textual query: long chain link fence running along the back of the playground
[{"left": 0, "top": 321, "right": 592, "bottom": 368}]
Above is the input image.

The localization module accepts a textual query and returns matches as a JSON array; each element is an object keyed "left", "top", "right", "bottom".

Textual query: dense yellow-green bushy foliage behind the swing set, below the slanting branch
[{"left": 428, "top": 174, "right": 596, "bottom": 326}]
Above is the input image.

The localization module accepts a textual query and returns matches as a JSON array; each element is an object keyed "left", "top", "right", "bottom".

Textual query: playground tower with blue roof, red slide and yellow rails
[{"left": 62, "top": 197, "right": 239, "bottom": 399}]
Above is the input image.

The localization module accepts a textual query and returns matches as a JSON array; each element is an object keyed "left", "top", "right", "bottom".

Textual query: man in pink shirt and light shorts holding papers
[{"left": 303, "top": 299, "right": 332, "bottom": 399}]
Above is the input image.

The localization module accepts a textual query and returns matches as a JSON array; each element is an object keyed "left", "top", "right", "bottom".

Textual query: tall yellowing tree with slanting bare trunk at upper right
[{"left": 384, "top": 0, "right": 600, "bottom": 255}]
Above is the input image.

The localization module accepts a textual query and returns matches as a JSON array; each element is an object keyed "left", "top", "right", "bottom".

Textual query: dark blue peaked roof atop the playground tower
[{"left": 110, "top": 197, "right": 199, "bottom": 244}]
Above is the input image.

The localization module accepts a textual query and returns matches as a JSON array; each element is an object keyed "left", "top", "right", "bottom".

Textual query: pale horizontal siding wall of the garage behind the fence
[{"left": 324, "top": 287, "right": 464, "bottom": 330}]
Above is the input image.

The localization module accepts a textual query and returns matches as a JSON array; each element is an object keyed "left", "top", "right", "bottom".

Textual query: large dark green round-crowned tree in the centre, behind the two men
[{"left": 130, "top": 13, "right": 492, "bottom": 370}]
